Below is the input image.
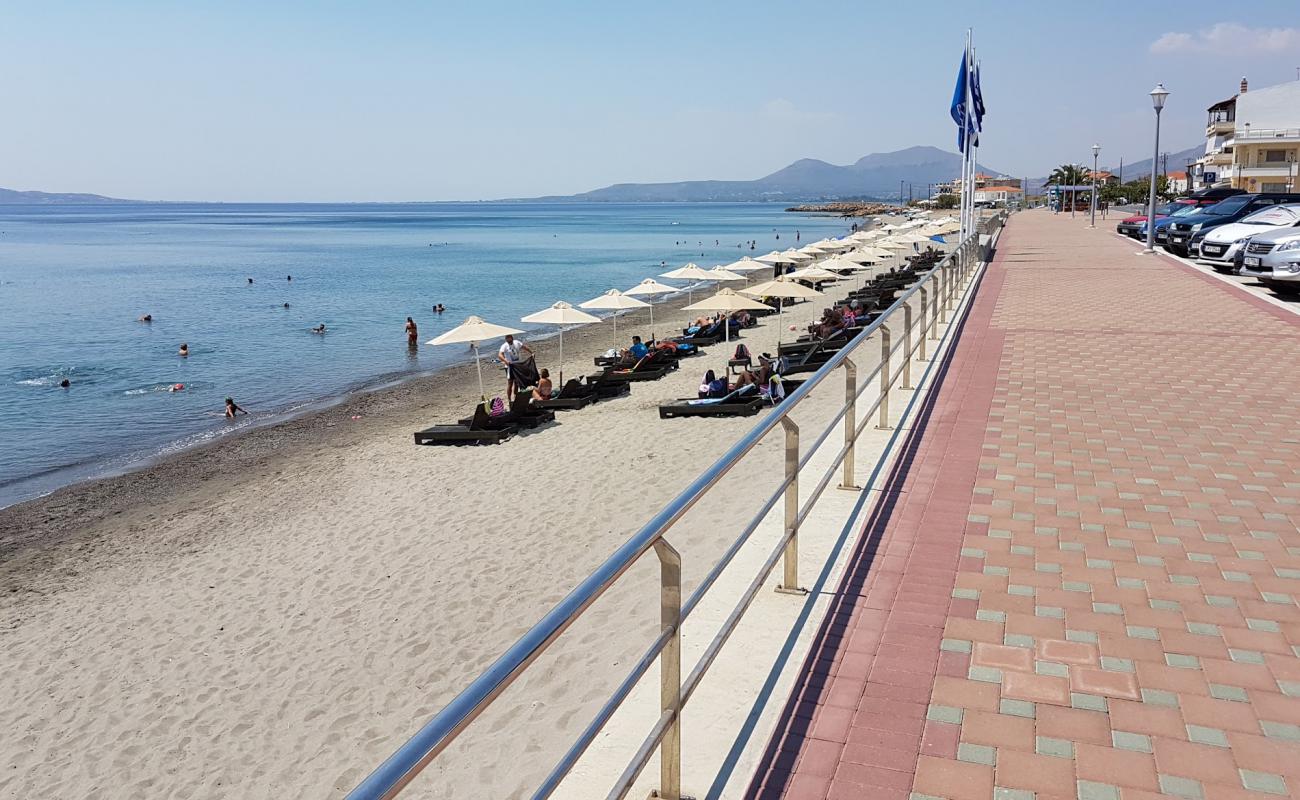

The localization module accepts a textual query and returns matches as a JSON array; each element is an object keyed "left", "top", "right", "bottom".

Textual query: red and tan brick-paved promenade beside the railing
[{"left": 749, "top": 211, "right": 1300, "bottom": 800}]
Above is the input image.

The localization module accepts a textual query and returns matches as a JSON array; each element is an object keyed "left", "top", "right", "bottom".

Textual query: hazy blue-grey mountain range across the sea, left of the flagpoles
[{"left": 534, "top": 147, "right": 995, "bottom": 203}]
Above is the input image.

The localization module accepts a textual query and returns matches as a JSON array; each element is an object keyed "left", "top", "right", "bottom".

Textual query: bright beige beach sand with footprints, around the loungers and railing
[{"left": 0, "top": 254, "right": 915, "bottom": 799}]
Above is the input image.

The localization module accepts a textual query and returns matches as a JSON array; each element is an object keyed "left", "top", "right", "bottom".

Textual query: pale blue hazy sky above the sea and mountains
[{"left": 0, "top": 0, "right": 1300, "bottom": 202}]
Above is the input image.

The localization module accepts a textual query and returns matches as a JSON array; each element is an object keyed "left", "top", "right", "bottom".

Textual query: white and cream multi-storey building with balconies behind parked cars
[{"left": 1190, "top": 78, "right": 1300, "bottom": 191}]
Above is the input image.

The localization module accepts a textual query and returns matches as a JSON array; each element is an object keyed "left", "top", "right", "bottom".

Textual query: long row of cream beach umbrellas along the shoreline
[{"left": 428, "top": 219, "right": 958, "bottom": 398}]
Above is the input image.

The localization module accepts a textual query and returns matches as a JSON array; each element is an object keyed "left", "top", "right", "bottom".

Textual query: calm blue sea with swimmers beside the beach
[{"left": 0, "top": 203, "right": 848, "bottom": 506}]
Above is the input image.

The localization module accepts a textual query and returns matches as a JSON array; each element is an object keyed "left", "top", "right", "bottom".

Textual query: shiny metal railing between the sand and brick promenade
[{"left": 347, "top": 212, "right": 1006, "bottom": 800}]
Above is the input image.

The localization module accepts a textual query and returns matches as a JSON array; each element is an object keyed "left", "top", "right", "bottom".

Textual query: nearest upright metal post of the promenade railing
[{"left": 654, "top": 539, "right": 681, "bottom": 800}]
